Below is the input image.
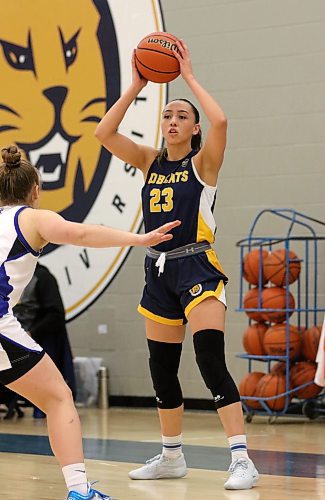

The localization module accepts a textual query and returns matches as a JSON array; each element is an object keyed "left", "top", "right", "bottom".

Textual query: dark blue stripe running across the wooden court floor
[{"left": 0, "top": 434, "right": 325, "bottom": 478}]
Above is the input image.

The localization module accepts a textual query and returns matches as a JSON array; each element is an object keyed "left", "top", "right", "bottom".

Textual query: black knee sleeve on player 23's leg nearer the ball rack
[{"left": 193, "top": 329, "right": 240, "bottom": 408}]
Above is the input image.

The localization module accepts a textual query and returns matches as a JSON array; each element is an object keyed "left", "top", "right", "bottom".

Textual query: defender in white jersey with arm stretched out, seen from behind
[{"left": 0, "top": 146, "right": 179, "bottom": 500}]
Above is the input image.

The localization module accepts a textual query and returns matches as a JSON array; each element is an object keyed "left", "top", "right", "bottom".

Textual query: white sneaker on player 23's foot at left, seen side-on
[{"left": 129, "top": 453, "right": 187, "bottom": 479}]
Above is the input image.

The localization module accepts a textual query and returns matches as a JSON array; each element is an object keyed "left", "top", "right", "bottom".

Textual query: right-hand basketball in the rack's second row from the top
[{"left": 262, "top": 286, "right": 295, "bottom": 323}]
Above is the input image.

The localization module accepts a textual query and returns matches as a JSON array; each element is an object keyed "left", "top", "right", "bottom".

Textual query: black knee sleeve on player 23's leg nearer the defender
[{"left": 148, "top": 339, "right": 183, "bottom": 409}]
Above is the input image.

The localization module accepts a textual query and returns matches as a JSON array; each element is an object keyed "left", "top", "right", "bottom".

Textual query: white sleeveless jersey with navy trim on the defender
[{"left": 0, "top": 206, "right": 39, "bottom": 316}]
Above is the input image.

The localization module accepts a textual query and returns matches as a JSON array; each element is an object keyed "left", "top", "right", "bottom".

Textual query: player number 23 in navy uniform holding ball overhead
[{"left": 96, "top": 41, "right": 258, "bottom": 489}]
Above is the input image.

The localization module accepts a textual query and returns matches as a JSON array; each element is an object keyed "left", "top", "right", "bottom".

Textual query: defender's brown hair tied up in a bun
[{"left": 0, "top": 146, "right": 40, "bottom": 205}]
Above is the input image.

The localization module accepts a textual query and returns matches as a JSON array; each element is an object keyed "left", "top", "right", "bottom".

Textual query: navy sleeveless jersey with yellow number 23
[{"left": 142, "top": 151, "right": 217, "bottom": 252}]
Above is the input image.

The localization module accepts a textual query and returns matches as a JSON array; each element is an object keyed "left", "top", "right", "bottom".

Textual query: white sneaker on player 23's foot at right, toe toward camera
[{"left": 224, "top": 458, "right": 259, "bottom": 490}]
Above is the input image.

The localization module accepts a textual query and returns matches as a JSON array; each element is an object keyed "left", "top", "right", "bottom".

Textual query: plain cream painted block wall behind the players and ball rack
[{"left": 69, "top": 0, "right": 325, "bottom": 398}]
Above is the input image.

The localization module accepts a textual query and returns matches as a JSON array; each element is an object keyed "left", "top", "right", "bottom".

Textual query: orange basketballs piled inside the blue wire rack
[{"left": 239, "top": 249, "right": 322, "bottom": 411}]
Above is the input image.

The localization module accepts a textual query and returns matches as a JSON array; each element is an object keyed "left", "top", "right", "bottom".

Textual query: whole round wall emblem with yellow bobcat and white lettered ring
[{"left": 0, "top": 0, "right": 167, "bottom": 319}]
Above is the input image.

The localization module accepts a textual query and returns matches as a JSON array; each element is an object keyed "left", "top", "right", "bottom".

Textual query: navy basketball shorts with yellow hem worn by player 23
[{"left": 138, "top": 248, "right": 228, "bottom": 326}]
